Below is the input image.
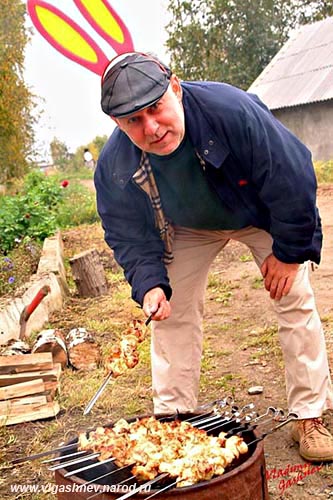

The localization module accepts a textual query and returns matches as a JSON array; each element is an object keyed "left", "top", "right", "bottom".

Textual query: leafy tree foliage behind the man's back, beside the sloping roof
[{"left": 166, "top": 0, "right": 333, "bottom": 89}]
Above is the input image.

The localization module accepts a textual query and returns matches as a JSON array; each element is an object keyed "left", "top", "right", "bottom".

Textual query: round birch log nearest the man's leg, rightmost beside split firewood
[{"left": 66, "top": 328, "right": 101, "bottom": 371}]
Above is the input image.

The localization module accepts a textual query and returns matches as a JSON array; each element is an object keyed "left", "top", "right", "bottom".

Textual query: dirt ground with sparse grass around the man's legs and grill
[{"left": 0, "top": 186, "right": 333, "bottom": 500}]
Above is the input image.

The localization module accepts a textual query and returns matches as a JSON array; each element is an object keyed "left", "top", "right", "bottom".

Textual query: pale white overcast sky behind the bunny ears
[{"left": 24, "top": 0, "right": 167, "bottom": 161}]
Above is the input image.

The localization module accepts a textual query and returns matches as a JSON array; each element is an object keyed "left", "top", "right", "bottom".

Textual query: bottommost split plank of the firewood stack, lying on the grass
[{"left": 0, "top": 401, "right": 60, "bottom": 425}]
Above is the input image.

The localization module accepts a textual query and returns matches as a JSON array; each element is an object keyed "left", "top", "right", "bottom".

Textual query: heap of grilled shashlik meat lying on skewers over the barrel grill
[{"left": 78, "top": 417, "right": 248, "bottom": 487}]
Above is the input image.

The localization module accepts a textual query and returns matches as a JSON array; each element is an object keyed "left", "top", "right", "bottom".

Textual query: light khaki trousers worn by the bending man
[{"left": 151, "top": 227, "right": 333, "bottom": 418}]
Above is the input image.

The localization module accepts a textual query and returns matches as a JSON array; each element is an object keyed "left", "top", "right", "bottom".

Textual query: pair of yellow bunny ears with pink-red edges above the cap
[{"left": 27, "top": 0, "right": 134, "bottom": 75}]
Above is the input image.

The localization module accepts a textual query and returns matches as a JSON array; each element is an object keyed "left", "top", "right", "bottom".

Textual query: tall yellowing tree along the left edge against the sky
[{"left": 0, "top": 0, "right": 34, "bottom": 183}]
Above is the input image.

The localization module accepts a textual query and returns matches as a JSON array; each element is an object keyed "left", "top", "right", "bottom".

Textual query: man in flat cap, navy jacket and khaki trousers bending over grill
[{"left": 95, "top": 53, "right": 333, "bottom": 461}]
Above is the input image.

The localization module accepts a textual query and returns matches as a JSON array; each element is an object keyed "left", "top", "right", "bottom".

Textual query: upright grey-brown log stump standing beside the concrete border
[{"left": 69, "top": 248, "right": 108, "bottom": 297}]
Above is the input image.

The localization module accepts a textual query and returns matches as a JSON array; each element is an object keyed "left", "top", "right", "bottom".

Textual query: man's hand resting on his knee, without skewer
[{"left": 260, "top": 254, "right": 299, "bottom": 300}]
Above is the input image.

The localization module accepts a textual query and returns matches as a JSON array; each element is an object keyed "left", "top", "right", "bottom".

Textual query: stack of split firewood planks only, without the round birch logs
[{"left": 0, "top": 352, "right": 61, "bottom": 425}]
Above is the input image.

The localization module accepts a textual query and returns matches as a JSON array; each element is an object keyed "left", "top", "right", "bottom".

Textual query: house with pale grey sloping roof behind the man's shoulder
[{"left": 248, "top": 17, "right": 333, "bottom": 161}]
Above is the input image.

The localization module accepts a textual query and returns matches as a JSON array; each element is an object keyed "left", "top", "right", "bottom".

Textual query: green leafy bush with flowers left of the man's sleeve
[{"left": 0, "top": 171, "right": 98, "bottom": 255}]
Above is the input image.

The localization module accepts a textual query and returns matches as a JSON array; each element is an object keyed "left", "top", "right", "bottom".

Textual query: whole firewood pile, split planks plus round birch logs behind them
[{"left": 0, "top": 328, "right": 101, "bottom": 426}]
